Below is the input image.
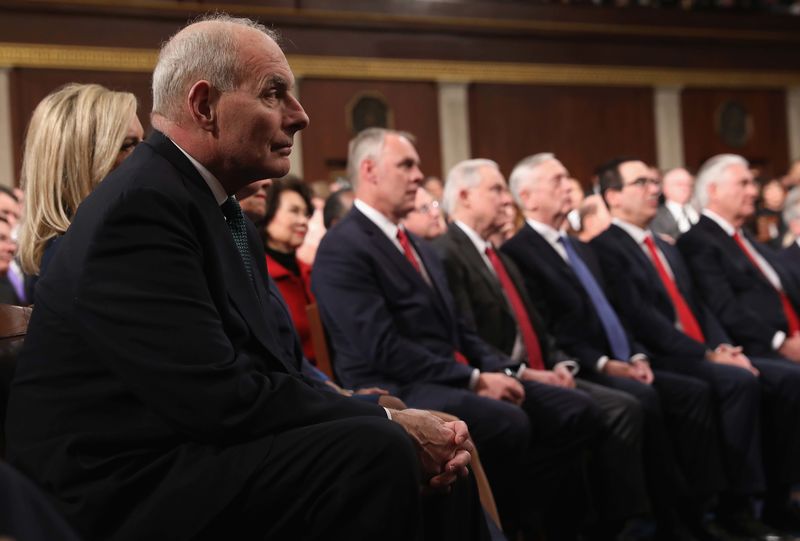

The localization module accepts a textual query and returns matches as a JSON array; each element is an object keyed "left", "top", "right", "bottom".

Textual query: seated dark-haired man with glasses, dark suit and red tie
[{"left": 592, "top": 158, "right": 800, "bottom": 537}]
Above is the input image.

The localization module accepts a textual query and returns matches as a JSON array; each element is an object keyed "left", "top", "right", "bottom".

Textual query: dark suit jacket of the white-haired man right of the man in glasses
[{"left": 678, "top": 216, "right": 800, "bottom": 356}]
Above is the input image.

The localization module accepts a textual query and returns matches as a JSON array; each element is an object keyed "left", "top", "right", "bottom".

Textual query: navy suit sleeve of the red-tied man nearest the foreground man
[{"left": 311, "top": 230, "right": 473, "bottom": 387}]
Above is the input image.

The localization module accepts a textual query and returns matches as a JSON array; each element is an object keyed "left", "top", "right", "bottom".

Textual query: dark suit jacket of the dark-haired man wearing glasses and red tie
[{"left": 591, "top": 224, "right": 728, "bottom": 359}]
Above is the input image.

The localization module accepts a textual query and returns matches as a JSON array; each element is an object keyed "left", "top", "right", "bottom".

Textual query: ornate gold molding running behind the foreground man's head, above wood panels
[{"left": 0, "top": 43, "right": 800, "bottom": 88}]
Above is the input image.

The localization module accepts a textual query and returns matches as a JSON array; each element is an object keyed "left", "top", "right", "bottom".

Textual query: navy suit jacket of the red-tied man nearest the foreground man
[{"left": 311, "top": 208, "right": 512, "bottom": 393}]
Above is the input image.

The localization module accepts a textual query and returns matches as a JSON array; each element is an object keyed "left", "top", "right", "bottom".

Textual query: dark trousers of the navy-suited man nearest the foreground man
[{"left": 398, "top": 382, "right": 602, "bottom": 535}]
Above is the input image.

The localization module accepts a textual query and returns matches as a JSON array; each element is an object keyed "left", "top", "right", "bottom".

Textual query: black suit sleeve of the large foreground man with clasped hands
[{"left": 74, "top": 189, "right": 385, "bottom": 443}]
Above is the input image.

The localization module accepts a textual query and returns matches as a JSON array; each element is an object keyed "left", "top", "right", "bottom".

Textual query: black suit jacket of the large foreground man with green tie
[{"left": 7, "top": 133, "right": 385, "bottom": 541}]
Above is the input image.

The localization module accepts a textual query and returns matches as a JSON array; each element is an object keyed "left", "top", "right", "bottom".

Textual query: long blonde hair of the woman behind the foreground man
[{"left": 18, "top": 83, "right": 136, "bottom": 274}]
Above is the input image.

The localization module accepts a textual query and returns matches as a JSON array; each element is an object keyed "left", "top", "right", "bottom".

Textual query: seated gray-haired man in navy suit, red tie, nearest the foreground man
[{"left": 312, "top": 129, "right": 602, "bottom": 539}]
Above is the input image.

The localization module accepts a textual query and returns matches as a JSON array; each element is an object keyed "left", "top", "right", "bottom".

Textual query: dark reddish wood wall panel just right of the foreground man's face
[{"left": 299, "top": 79, "right": 441, "bottom": 181}]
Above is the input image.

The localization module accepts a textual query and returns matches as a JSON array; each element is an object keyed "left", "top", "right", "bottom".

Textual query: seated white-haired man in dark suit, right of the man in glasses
[{"left": 678, "top": 154, "right": 800, "bottom": 529}]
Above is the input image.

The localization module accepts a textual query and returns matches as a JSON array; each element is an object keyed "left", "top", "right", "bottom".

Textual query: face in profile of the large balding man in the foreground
[{"left": 216, "top": 28, "right": 308, "bottom": 183}]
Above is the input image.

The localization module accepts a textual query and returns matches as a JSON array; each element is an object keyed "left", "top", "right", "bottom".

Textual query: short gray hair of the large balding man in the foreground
[{"left": 153, "top": 13, "right": 278, "bottom": 121}]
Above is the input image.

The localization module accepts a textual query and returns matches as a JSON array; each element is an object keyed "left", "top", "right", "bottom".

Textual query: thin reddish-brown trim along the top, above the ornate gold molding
[{"left": 9, "top": 0, "right": 800, "bottom": 42}]
